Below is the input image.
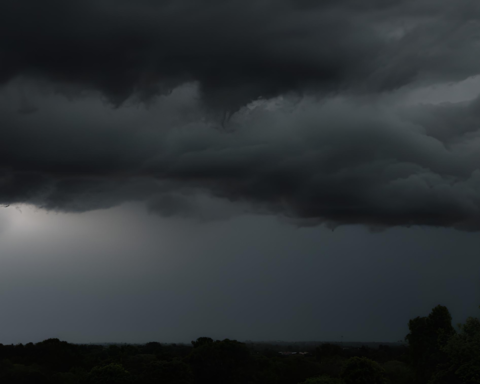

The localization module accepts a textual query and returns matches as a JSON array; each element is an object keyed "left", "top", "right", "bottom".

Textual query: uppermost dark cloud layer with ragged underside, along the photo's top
[{"left": 0, "top": 0, "right": 480, "bottom": 111}]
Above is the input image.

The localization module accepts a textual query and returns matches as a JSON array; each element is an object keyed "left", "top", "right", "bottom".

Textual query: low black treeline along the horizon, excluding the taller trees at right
[{"left": 0, "top": 337, "right": 412, "bottom": 384}]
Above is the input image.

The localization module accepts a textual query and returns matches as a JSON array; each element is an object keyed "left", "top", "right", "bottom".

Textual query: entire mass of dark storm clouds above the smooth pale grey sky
[{"left": 0, "top": 0, "right": 480, "bottom": 230}]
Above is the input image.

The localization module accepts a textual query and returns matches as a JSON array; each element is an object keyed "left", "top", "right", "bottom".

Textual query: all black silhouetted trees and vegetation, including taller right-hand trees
[{"left": 0, "top": 306, "right": 480, "bottom": 384}]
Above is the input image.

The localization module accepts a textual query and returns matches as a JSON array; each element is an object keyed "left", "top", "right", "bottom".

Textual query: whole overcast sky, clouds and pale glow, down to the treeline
[{"left": 0, "top": 0, "right": 480, "bottom": 344}]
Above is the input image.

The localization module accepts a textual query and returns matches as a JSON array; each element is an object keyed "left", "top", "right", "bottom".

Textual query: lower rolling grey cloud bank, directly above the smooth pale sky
[{"left": 0, "top": 79, "right": 480, "bottom": 230}]
